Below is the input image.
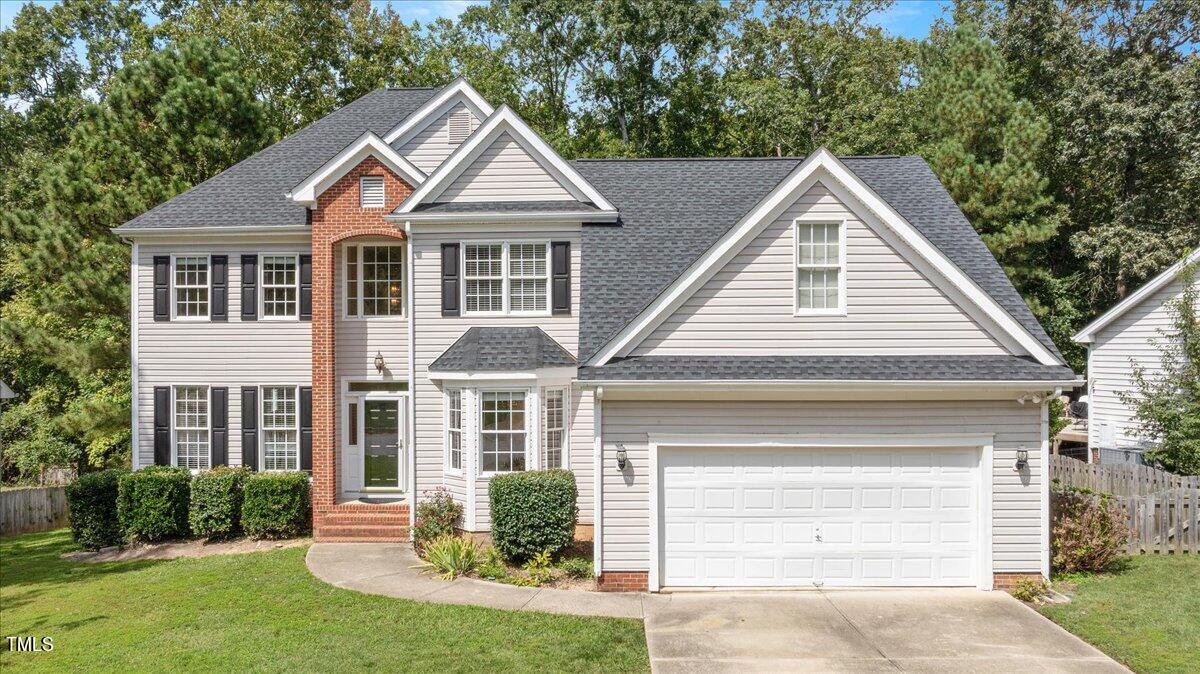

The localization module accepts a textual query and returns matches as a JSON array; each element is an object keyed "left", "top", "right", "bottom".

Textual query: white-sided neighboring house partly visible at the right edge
[{"left": 1074, "top": 248, "right": 1200, "bottom": 463}]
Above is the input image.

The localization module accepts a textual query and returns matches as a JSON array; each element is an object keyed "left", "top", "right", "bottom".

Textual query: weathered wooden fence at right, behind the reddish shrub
[{"left": 1050, "top": 456, "right": 1200, "bottom": 554}]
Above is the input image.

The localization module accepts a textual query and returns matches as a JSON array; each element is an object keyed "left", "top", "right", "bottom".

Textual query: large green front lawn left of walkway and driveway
[{"left": 0, "top": 531, "right": 649, "bottom": 673}]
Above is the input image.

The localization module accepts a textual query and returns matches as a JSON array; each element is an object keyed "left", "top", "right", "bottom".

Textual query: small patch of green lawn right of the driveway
[{"left": 1042, "top": 555, "right": 1200, "bottom": 672}]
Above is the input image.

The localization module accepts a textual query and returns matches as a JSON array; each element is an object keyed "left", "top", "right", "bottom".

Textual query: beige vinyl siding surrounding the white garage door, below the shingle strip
[{"left": 602, "top": 399, "right": 1044, "bottom": 572}]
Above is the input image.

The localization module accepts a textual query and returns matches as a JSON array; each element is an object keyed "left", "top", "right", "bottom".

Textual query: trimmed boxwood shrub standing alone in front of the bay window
[{"left": 487, "top": 469, "right": 576, "bottom": 561}]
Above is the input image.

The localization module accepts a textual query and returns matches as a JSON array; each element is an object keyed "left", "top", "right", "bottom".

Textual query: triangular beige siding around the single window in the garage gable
[{"left": 634, "top": 185, "right": 1008, "bottom": 355}]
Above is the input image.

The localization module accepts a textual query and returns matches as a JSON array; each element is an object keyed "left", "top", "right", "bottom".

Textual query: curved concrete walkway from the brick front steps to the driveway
[{"left": 306, "top": 543, "right": 665, "bottom": 619}]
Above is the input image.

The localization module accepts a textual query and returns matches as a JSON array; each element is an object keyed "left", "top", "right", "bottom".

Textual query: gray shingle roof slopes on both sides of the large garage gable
[{"left": 572, "top": 157, "right": 1058, "bottom": 361}]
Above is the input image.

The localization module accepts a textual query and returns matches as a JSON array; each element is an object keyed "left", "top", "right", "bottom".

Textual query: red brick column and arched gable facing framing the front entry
[{"left": 312, "top": 156, "right": 413, "bottom": 538}]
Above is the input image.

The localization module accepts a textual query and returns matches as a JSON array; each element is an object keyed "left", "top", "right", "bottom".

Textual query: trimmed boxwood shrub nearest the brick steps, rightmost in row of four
[{"left": 241, "top": 473, "right": 312, "bottom": 538}]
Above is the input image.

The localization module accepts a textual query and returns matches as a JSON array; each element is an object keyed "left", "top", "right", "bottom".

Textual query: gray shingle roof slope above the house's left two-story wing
[{"left": 116, "top": 88, "right": 438, "bottom": 231}]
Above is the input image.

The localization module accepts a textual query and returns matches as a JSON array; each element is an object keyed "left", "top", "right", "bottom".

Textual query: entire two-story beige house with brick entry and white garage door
[{"left": 118, "top": 80, "right": 1076, "bottom": 590}]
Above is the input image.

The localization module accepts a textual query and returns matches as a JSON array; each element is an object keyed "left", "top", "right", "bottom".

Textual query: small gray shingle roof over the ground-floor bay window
[{"left": 430, "top": 326, "right": 577, "bottom": 372}]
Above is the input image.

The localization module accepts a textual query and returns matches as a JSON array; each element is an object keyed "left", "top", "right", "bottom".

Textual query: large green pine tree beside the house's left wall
[{"left": 0, "top": 41, "right": 275, "bottom": 477}]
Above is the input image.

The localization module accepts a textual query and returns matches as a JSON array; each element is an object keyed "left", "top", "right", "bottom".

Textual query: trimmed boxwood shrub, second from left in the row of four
[{"left": 116, "top": 465, "right": 192, "bottom": 541}]
